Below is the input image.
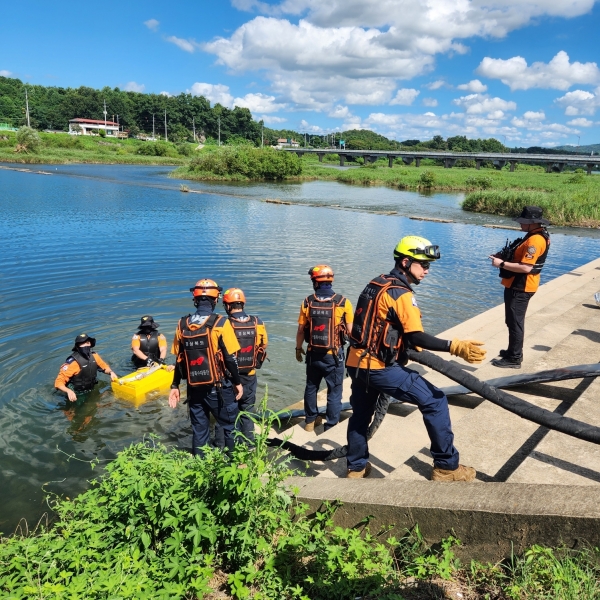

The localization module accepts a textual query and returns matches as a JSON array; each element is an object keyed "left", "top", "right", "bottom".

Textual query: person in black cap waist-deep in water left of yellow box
[{"left": 54, "top": 333, "right": 118, "bottom": 402}]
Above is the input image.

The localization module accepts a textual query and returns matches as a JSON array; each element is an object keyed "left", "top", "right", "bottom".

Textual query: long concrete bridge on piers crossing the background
[{"left": 283, "top": 148, "right": 600, "bottom": 175}]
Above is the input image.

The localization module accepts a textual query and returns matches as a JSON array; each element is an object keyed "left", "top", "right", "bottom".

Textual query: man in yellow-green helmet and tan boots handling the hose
[{"left": 346, "top": 235, "right": 486, "bottom": 481}]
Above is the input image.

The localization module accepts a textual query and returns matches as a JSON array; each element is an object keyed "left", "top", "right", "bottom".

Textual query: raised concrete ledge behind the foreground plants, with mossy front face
[{"left": 289, "top": 477, "right": 600, "bottom": 562}]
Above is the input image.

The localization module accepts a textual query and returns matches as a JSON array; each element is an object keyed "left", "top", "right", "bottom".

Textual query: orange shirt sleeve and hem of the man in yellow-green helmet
[{"left": 346, "top": 269, "right": 424, "bottom": 369}]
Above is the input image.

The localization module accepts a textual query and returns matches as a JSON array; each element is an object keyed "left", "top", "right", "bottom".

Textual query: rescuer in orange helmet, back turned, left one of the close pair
[{"left": 169, "top": 279, "right": 244, "bottom": 455}]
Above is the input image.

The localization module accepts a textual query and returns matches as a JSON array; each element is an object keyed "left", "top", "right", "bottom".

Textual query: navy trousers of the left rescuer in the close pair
[{"left": 187, "top": 382, "right": 239, "bottom": 456}]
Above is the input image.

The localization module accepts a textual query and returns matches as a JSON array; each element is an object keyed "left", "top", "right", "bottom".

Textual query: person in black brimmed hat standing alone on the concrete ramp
[{"left": 490, "top": 206, "right": 550, "bottom": 369}]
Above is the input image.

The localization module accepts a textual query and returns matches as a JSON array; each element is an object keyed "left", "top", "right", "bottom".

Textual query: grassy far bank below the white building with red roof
[{"left": 0, "top": 132, "right": 195, "bottom": 165}]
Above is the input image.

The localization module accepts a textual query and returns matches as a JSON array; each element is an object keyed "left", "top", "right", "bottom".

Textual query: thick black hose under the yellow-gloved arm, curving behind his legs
[{"left": 267, "top": 350, "right": 600, "bottom": 461}]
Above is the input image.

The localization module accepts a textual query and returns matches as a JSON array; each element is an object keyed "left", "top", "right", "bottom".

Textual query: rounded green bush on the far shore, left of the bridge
[{"left": 171, "top": 146, "right": 302, "bottom": 181}]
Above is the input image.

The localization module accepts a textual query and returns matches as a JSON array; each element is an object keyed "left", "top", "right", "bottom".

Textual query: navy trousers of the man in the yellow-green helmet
[{"left": 346, "top": 363, "right": 458, "bottom": 471}]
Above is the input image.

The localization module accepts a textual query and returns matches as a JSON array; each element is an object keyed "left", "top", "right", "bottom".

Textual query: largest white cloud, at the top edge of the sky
[{"left": 202, "top": 0, "right": 595, "bottom": 110}]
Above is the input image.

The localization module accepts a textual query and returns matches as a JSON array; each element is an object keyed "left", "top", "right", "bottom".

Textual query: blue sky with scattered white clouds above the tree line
[{"left": 0, "top": 0, "right": 600, "bottom": 146}]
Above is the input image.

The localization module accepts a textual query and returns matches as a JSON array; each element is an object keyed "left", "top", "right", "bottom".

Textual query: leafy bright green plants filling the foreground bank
[{"left": 0, "top": 396, "right": 600, "bottom": 600}]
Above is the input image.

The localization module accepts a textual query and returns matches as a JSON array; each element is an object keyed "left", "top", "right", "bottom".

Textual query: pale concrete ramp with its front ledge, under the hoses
[{"left": 277, "top": 259, "right": 600, "bottom": 559}]
